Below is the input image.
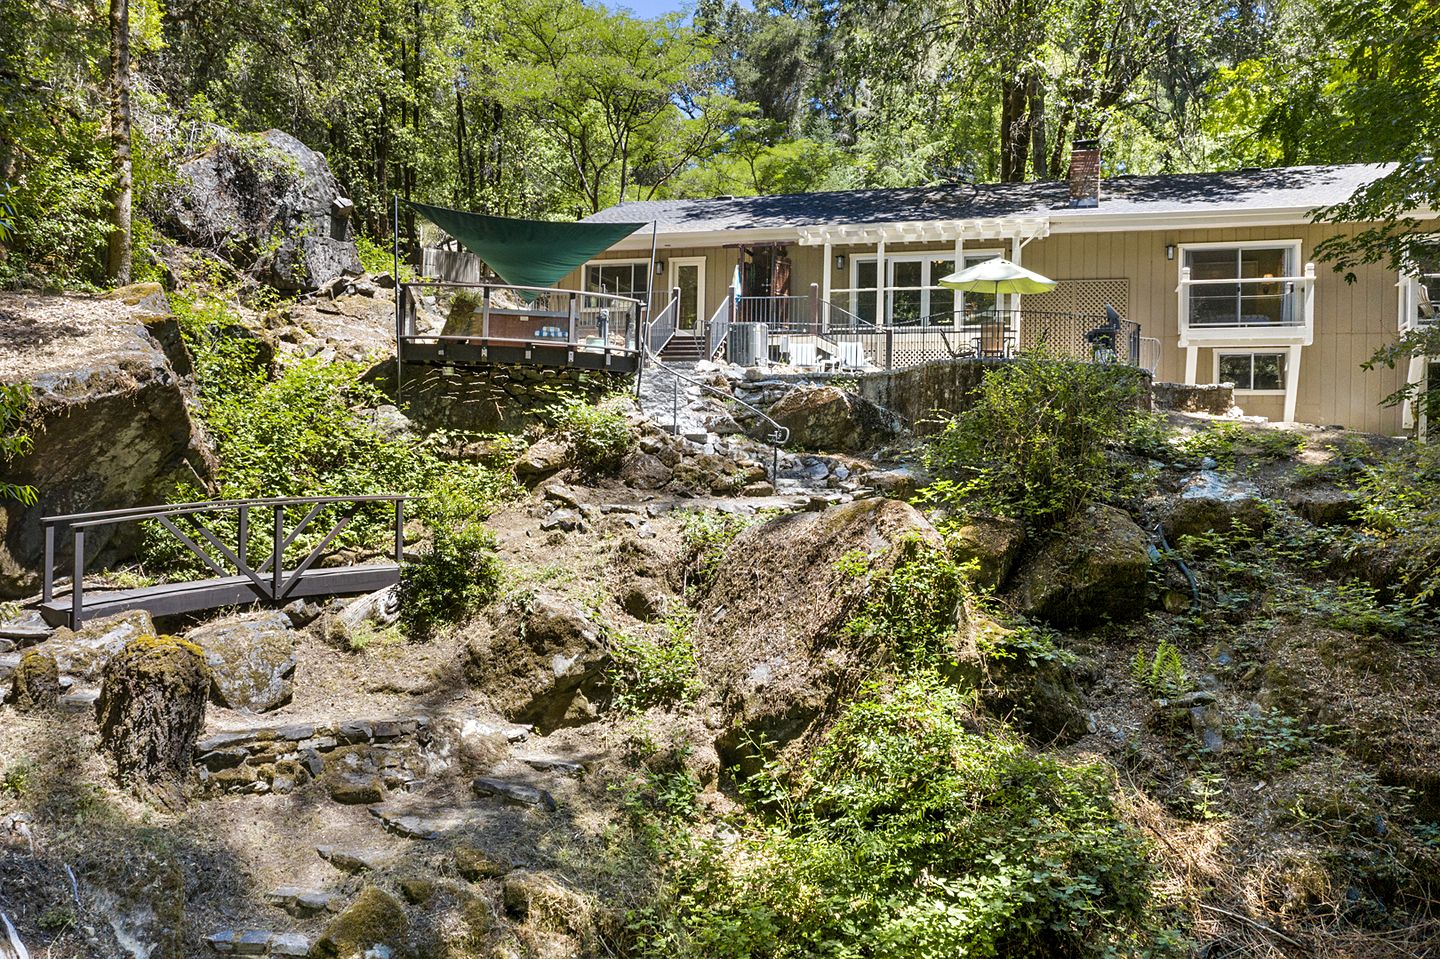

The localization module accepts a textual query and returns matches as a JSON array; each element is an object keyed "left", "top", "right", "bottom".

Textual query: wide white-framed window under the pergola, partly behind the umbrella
[{"left": 850, "top": 249, "right": 1001, "bottom": 325}]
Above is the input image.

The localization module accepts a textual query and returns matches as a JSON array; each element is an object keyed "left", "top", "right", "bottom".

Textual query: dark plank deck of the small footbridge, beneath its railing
[{"left": 40, "top": 563, "right": 400, "bottom": 626}]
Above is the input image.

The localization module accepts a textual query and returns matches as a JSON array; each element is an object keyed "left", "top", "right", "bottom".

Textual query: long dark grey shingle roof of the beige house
[{"left": 586, "top": 164, "right": 1392, "bottom": 233}]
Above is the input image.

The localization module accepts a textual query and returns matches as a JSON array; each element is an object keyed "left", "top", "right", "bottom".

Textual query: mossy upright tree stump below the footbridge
[{"left": 95, "top": 636, "right": 210, "bottom": 805}]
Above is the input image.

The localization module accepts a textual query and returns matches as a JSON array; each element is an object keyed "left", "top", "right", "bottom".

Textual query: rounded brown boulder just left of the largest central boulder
[{"left": 465, "top": 592, "right": 611, "bottom": 731}]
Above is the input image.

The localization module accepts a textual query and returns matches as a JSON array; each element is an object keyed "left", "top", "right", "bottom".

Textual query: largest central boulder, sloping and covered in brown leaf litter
[{"left": 694, "top": 498, "right": 942, "bottom": 769}]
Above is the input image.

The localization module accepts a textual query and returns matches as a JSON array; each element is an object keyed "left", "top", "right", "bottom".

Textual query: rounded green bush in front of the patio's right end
[{"left": 922, "top": 356, "right": 1139, "bottom": 527}]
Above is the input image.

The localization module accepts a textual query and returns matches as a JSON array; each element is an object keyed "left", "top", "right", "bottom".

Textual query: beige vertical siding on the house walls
[{"left": 562, "top": 218, "right": 1422, "bottom": 433}]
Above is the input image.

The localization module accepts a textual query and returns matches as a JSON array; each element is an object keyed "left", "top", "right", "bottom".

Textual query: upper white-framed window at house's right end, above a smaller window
[{"left": 1179, "top": 240, "right": 1305, "bottom": 330}]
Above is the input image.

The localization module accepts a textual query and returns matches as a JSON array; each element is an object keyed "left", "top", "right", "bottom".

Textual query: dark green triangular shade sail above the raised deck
[{"left": 410, "top": 203, "right": 649, "bottom": 287}]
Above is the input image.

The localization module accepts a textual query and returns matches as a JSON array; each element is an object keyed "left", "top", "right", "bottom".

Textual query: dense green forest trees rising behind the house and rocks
[{"left": 0, "top": 0, "right": 1440, "bottom": 284}]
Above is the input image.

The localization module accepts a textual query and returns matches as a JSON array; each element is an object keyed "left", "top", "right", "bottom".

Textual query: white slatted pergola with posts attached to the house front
[{"left": 799, "top": 216, "right": 1050, "bottom": 310}]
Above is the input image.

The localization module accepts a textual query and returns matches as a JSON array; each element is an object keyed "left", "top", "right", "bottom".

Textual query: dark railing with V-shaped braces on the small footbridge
[{"left": 40, "top": 492, "right": 412, "bottom": 628}]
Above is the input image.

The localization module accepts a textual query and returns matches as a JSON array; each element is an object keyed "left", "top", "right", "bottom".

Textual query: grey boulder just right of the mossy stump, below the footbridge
[{"left": 186, "top": 609, "right": 295, "bottom": 713}]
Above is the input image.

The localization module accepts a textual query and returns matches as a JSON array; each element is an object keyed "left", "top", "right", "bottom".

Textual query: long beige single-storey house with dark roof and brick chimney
[{"left": 559, "top": 143, "right": 1440, "bottom": 433}]
